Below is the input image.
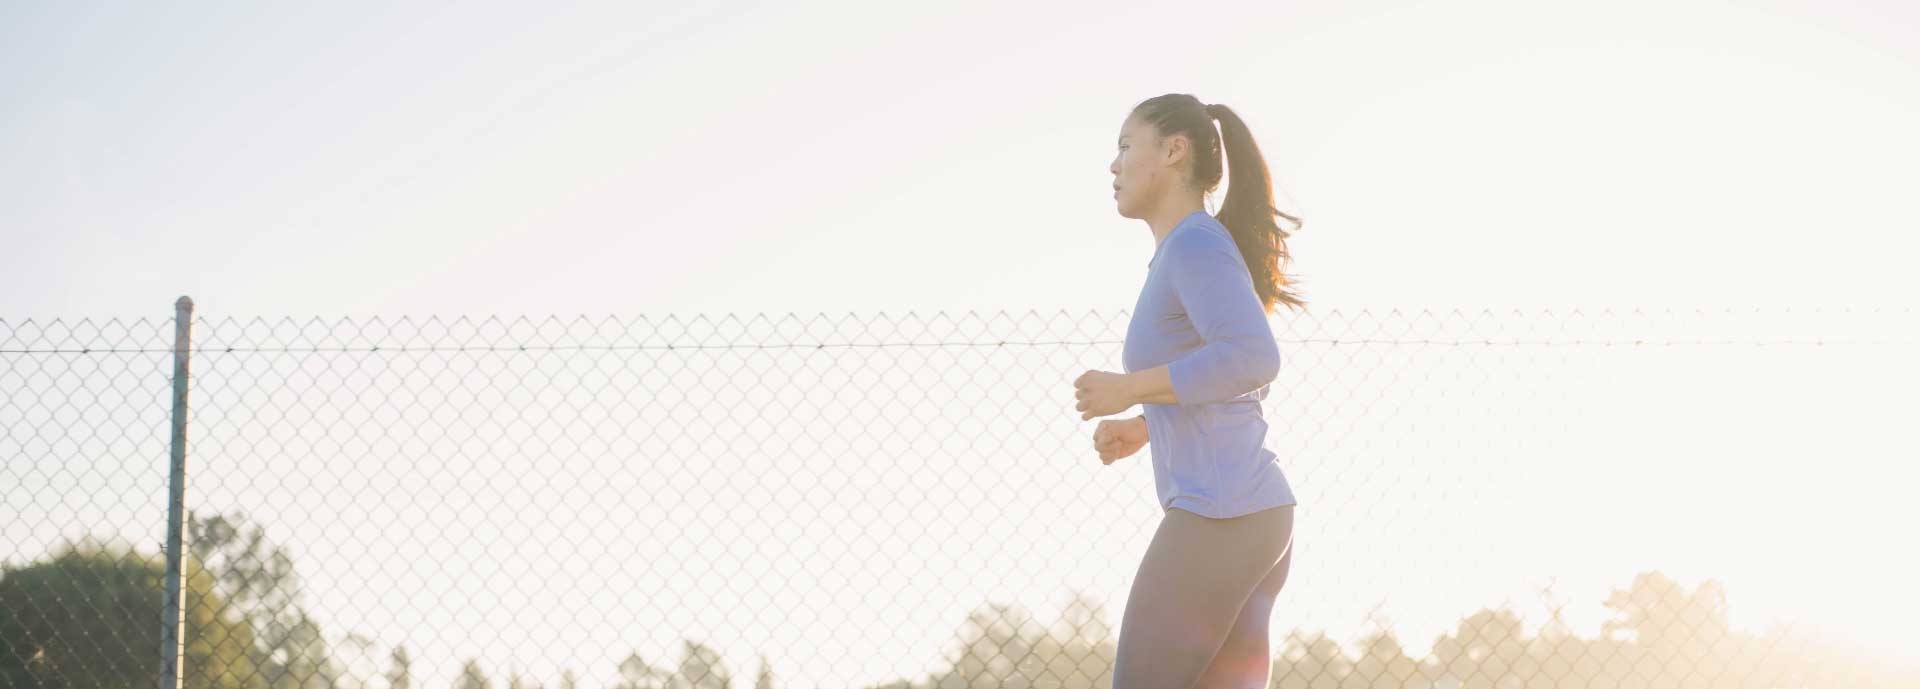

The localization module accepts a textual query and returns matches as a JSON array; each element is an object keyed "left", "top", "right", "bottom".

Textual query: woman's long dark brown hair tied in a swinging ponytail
[{"left": 1133, "top": 94, "right": 1306, "bottom": 313}]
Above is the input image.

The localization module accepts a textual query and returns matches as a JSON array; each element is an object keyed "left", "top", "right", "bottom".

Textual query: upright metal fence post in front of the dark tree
[{"left": 159, "top": 297, "right": 194, "bottom": 689}]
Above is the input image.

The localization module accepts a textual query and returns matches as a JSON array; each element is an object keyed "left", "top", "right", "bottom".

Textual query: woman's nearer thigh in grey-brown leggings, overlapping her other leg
[{"left": 1114, "top": 507, "right": 1294, "bottom": 689}]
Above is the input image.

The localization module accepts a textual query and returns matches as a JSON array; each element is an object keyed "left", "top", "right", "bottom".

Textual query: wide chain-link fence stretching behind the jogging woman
[{"left": 0, "top": 309, "right": 1920, "bottom": 689}]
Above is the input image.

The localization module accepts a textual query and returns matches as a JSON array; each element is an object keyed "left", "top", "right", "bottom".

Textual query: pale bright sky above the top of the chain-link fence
[{"left": 0, "top": 2, "right": 1920, "bottom": 677}]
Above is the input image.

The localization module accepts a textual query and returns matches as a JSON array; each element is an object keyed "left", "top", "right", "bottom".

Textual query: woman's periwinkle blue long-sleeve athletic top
[{"left": 1121, "top": 211, "right": 1296, "bottom": 518}]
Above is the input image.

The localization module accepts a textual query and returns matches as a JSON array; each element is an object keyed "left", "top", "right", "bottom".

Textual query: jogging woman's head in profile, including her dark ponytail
[{"left": 1108, "top": 94, "right": 1306, "bottom": 311}]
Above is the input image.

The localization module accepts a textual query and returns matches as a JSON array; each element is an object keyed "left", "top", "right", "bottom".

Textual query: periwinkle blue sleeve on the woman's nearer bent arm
[{"left": 1167, "top": 232, "right": 1281, "bottom": 405}]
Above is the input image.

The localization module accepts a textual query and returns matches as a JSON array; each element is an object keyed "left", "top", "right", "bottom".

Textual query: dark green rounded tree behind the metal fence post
[{"left": 0, "top": 541, "right": 265, "bottom": 689}]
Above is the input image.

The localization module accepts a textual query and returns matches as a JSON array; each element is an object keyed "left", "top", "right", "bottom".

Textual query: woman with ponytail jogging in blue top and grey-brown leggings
[{"left": 1073, "top": 94, "right": 1304, "bottom": 689}]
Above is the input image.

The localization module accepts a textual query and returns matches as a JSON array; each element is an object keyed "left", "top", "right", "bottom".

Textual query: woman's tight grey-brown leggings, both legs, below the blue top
[{"left": 1114, "top": 505, "right": 1294, "bottom": 689}]
